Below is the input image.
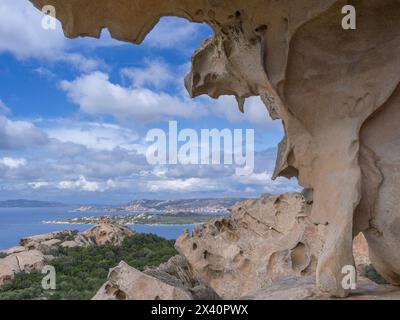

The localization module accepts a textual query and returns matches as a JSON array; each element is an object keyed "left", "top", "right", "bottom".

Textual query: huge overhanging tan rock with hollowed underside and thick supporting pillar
[{"left": 32, "top": 0, "right": 400, "bottom": 296}]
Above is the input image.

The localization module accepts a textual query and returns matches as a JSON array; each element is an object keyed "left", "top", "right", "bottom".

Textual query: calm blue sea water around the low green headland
[{"left": 0, "top": 208, "right": 195, "bottom": 250}]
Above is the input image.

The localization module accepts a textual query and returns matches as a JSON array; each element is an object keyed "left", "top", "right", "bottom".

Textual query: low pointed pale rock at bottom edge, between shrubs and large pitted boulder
[{"left": 93, "top": 256, "right": 219, "bottom": 300}]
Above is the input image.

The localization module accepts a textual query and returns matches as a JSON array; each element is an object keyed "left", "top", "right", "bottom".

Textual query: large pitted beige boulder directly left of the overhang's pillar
[{"left": 175, "top": 193, "right": 323, "bottom": 299}]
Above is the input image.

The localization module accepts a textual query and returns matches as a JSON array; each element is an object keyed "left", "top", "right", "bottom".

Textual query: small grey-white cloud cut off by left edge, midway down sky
[{"left": 0, "top": 115, "right": 48, "bottom": 149}]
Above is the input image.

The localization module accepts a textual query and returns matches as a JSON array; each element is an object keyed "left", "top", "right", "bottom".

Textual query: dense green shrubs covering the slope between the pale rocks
[{"left": 0, "top": 234, "right": 176, "bottom": 300}]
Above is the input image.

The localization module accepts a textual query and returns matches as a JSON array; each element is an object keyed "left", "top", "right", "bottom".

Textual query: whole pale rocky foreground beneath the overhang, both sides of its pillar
[{"left": 94, "top": 193, "right": 398, "bottom": 299}]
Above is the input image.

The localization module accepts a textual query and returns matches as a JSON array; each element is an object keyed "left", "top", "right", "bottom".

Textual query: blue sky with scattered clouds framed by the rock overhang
[{"left": 0, "top": 0, "right": 297, "bottom": 204}]
